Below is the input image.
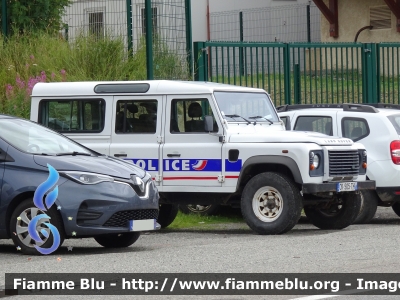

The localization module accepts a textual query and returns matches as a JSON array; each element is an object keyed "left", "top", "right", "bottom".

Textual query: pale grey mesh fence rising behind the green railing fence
[{"left": 210, "top": 3, "right": 321, "bottom": 42}]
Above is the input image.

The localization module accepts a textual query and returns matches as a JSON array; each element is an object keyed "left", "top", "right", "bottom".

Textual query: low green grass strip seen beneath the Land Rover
[{"left": 167, "top": 212, "right": 244, "bottom": 230}]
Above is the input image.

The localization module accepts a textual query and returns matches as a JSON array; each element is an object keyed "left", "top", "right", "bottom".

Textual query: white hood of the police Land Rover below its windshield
[{"left": 229, "top": 127, "right": 353, "bottom": 146}]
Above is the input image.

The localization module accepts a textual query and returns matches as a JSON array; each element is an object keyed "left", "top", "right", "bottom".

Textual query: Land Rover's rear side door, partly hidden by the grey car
[{"left": 110, "top": 95, "right": 163, "bottom": 185}]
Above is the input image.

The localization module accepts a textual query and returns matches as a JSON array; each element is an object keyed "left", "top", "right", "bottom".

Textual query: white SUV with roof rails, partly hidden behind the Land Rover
[{"left": 277, "top": 104, "right": 400, "bottom": 223}]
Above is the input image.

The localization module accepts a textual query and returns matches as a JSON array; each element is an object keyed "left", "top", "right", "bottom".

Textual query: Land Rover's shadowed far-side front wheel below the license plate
[{"left": 304, "top": 193, "right": 361, "bottom": 229}]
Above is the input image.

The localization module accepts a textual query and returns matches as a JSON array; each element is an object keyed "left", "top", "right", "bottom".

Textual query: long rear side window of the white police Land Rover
[{"left": 38, "top": 99, "right": 106, "bottom": 132}]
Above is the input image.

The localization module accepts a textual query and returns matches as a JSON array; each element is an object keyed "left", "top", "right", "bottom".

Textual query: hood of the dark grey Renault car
[{"left": 33, "top": 155, "right": 146, "bottom": 179}]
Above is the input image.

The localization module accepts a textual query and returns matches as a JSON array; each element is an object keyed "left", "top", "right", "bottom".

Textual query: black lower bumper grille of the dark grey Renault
[{"left": 103, "top": 209, "right": 158, "bottom": 227}]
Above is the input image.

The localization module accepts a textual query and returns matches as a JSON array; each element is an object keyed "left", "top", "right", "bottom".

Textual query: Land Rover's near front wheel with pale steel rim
[{"left": 241, "top": 172, "right": 302, "bottom": 234}]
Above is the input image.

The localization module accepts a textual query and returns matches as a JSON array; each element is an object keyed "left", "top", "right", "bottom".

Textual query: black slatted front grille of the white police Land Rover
[{"left": 328, "top": 150, "right": 360, "bottom": 177}]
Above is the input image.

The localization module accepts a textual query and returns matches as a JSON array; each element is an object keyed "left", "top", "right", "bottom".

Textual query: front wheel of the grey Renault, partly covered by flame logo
[{"left": 10, "top": 198, "right": 64, "bottom": 255}]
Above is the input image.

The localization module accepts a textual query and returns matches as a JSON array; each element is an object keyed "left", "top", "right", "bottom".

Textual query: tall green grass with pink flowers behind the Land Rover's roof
[{"left": 0, "top": 33, "right": 190, "bottom": 118}]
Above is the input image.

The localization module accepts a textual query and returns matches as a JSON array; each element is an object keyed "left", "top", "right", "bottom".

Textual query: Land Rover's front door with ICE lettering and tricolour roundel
[{"left": 162, "top": 95, "right": 223, "bottom": 187}]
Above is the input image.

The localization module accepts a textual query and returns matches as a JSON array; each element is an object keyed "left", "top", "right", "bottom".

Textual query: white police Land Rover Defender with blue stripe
[{"left": 31, "top": 81, "right": 375, "bottom": 234}]
